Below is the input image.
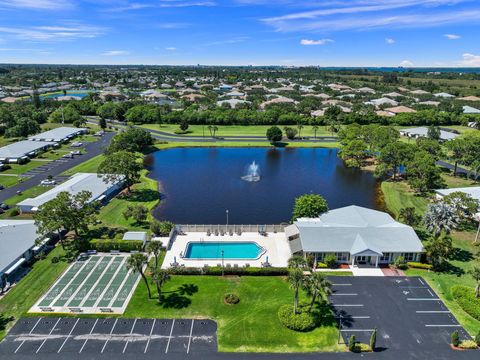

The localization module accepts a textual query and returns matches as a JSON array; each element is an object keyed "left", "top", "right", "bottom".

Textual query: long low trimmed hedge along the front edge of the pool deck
[{"left": 168, "top": 266, "right": 288, "bottom": 276}]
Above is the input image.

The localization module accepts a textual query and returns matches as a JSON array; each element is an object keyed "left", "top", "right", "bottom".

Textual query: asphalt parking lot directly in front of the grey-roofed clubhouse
[{"left": 330, "top": 277, "right": 469, "bottom": 350}]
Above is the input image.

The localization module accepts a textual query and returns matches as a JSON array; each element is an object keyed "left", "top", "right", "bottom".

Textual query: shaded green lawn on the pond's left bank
[{"left": 98, "top": 170, "right": 160, "bottom": 230}]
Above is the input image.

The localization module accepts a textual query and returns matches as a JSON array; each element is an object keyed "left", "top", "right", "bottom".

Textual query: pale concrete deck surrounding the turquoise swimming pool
[{"left": 162, "top": 232, "right": 291, "bottom": 269}]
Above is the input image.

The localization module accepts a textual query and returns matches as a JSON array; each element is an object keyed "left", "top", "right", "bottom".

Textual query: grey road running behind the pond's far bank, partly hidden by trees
[{"left": 87, "top": 116, "right": 338, "bottom": 143}]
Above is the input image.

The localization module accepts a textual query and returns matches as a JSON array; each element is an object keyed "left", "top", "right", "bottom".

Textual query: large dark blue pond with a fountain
[{"left": 149, "top": 148, "right": 377, "bottom": 224}]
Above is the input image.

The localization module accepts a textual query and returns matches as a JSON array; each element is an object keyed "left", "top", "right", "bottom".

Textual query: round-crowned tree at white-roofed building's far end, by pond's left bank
[{"left": 97, "top": 151, "right": 143, "bottom": 193}]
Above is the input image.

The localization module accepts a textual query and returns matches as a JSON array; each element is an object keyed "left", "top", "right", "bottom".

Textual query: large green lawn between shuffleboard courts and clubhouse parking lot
[{"left": 125, "top": 276, "right": 344, "bottom": 352}]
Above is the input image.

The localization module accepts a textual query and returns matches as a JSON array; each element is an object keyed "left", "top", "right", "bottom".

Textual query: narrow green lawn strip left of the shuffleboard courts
[{"left": 0, "top": 246, "right": 68, "bottom": 339}]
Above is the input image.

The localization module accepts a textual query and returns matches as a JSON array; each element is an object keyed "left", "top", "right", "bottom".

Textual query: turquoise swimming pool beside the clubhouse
[{"left": 183, "top": 241, "right": 265, "bottom": 260}]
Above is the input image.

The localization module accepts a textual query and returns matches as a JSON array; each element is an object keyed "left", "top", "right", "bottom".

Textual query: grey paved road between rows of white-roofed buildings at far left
[{"left": 0, "top": 132, "right": 115, "bottom": 202}]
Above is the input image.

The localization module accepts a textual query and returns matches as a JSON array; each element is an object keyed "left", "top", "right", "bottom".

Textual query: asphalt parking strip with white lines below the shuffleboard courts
[{"left": 0, "top": 318, "right": 217, "bottom": 359}]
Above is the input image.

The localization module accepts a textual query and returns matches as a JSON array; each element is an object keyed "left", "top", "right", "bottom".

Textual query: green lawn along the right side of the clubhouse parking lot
[{"left": 407, "top": 232, "right": 480, "bottom": 335}]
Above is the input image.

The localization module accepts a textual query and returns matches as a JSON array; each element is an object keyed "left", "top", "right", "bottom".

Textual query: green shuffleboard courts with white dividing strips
[{"left": 30, "top": 254, "right": 139, "bottom": 314}]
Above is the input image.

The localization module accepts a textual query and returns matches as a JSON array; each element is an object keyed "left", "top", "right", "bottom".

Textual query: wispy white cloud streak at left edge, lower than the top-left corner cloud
[{"left": 0, "top": 24, "right": 104, "bottom": 41}]
